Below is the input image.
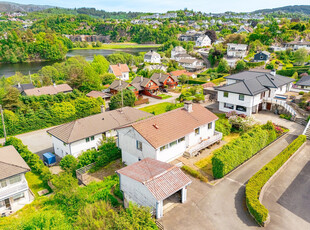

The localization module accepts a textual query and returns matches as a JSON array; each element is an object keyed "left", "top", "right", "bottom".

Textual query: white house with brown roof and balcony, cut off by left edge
[{"left": 0, "top": 145, "right": 33, "bottom": 216}]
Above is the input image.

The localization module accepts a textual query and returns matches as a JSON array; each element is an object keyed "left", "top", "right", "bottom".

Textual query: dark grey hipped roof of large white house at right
[{"left": 217, "top": 71, "right": 294, "bottom": 96}]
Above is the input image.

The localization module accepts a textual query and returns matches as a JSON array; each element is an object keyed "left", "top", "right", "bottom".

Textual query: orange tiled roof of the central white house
[{"left": 120, "top": 104, "right": 218, "bottom": 149}]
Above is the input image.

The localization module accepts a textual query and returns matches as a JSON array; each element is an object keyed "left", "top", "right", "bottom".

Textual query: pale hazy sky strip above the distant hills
[{"left": 6, "top": 0, "right": 310, "bottom": 12}]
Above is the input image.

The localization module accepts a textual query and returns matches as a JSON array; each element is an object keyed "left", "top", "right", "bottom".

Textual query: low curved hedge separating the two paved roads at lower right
[{"left": 245, "top": 135, "right": 306, "bottom": 225}]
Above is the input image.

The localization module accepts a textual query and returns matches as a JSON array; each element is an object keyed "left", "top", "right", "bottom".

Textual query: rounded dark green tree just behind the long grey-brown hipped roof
[{"left": 109, "top": 90, "right": 136, "bottom": 110}]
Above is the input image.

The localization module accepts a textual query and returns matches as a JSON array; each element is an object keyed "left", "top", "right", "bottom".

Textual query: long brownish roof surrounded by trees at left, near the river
[{"left": 23, "top": 84, "right": 72, "bottom": 96}]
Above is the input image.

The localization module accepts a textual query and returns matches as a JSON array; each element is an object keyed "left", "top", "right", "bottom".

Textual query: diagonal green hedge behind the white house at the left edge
[{"left": 5, "top": 137, "right": 52, "bottom": 181}]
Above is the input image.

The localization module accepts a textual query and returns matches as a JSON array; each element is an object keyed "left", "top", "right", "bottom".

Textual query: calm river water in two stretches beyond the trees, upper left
[{"left": 0, "top": 48, "right": 157, "bottom": 77}]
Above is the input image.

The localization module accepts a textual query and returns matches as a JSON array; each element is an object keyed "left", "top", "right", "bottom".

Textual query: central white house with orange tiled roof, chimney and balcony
[{"left": 117, "top": 102, "right": 222, "bottom": 165}]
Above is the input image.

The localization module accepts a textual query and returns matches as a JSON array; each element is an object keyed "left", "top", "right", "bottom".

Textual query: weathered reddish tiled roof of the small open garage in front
[{"left": 117, "top": 158, "right": 192, "bottom": 200}]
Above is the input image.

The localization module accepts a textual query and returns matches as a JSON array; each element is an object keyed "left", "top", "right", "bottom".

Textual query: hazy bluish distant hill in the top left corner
[{"left": 0, "top": 1, "right": 54, "bottom": 12}]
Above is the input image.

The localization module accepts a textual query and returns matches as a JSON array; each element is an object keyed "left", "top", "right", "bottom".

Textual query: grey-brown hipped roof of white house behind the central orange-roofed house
[{"left": 47, "top": 107, "right": 152, "bottom": 143}]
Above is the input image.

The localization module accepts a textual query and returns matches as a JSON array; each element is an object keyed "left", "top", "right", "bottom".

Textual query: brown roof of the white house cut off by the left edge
[{"left": 0, "top": 145, "right": 30, "bottom": 180}]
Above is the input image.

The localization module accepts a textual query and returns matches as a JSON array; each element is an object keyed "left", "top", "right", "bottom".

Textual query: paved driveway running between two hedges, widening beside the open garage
[{"left": 160, "top": 113, "right": 308, "bottom": 230}]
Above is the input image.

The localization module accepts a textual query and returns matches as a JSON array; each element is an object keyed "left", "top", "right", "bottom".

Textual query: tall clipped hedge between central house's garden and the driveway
[{"left": 212, "top": 123, "right": 277, "bottom": 178}]
